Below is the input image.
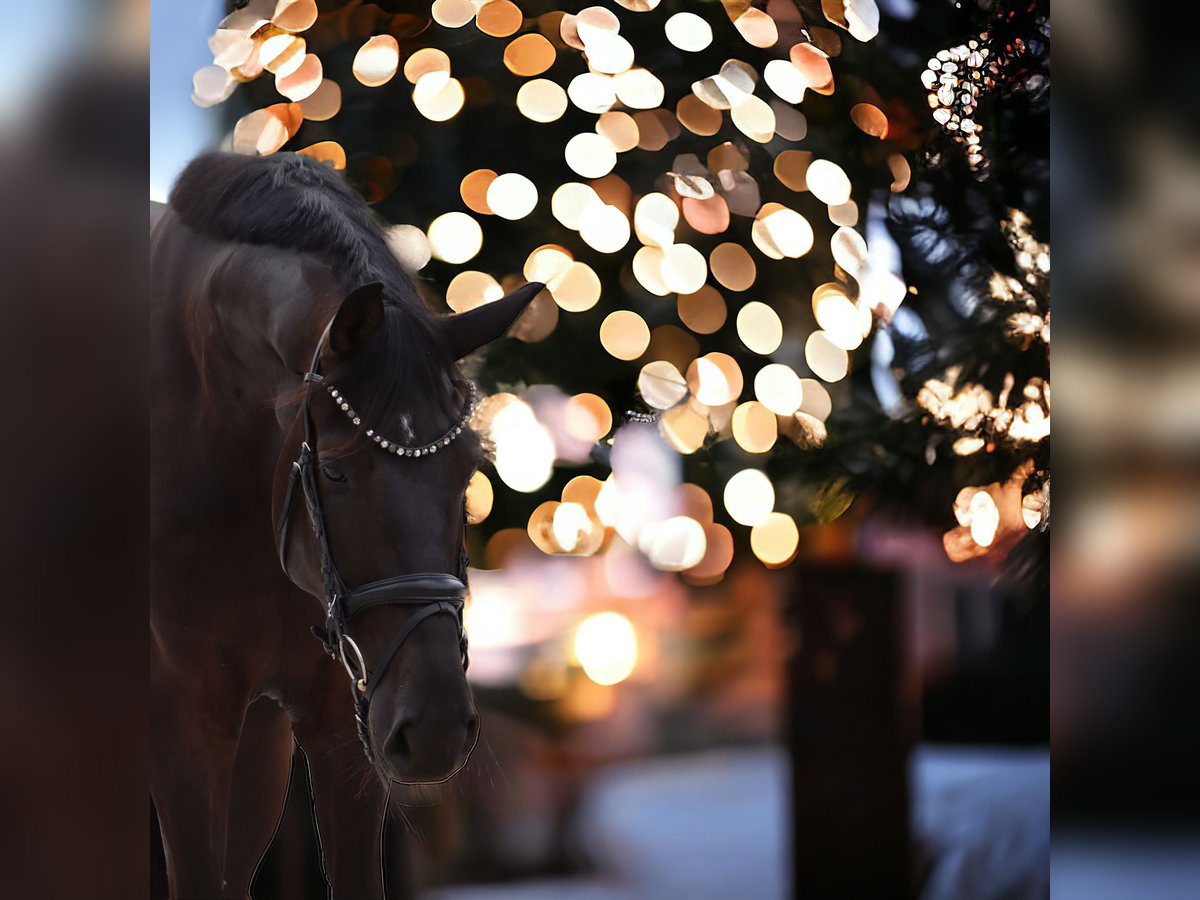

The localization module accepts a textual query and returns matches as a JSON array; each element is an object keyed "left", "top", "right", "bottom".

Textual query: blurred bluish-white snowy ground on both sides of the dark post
[{"left": 426, "top": 748, "right": 1050, "bottom": 900}]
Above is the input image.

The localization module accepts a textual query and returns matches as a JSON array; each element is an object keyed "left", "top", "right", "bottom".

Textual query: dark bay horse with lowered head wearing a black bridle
[{"left": 150, "top": 154, "right": 542, "bottom": 900}]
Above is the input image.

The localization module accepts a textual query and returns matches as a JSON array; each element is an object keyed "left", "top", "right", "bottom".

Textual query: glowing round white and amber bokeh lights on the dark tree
[{"left": 192, "top": 0, "right": 1048, "bottom": 583}]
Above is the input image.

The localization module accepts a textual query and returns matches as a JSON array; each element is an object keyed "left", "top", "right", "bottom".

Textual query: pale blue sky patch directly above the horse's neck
[{"left": 150, "top": 0, "right": 223, "bottom": 200}]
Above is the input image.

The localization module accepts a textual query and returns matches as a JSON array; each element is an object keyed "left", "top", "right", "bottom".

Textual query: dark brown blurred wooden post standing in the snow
[{"left": 786, "top": 564, "right": 914, "bottom": 900}]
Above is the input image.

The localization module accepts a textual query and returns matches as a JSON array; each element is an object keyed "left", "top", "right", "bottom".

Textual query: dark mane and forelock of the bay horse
[{"left": 169, "top": 152, "right": 454, "bottom": 434}]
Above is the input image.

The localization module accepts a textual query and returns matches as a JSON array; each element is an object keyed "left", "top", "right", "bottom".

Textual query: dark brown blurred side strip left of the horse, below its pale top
[{"left": 0, "top": 64, "right": 148, "bottom": 900}]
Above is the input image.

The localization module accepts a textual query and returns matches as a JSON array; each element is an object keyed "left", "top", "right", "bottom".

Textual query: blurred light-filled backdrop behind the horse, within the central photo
[{"left": 150, "top": 0, "right": 1050, "bottom": 900}]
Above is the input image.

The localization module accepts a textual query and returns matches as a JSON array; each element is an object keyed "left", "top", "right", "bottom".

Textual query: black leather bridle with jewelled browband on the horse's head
[{"left": 275, "top": 323, "right": 475, "bottom": 762}]
